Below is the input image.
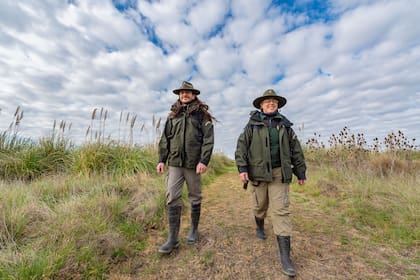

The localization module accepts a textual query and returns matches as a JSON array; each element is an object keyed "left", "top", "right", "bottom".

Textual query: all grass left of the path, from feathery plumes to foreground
[{"left": 0, "top": 108, "right": 232, "bottom": 279}]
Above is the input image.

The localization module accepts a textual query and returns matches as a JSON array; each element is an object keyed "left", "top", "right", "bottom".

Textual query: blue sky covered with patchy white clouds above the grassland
[{"left": 0, "top": 0, "right": 420, "bottom": 157}]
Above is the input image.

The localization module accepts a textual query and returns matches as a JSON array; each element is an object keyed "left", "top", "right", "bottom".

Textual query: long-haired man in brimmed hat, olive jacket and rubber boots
[{"left": 156, "top": 81, "right": 215, "bottom": 254}]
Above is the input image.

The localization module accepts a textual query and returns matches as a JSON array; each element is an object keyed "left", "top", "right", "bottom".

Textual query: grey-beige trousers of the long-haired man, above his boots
[{"left": 166, "top": 166, "right": 202, "bottom": 207}]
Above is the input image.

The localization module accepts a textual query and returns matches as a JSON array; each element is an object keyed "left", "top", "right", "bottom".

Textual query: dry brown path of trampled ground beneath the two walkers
[{"left": 124, "top": 173, "right": 403, "bottom": 280}]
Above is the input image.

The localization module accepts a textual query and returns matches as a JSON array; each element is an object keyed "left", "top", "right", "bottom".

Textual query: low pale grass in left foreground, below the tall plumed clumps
[{"left": 0, "top": 155, "right": 232, "bottom": 279}]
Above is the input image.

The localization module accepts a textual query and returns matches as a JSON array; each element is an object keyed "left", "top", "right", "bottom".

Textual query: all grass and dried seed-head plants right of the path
[{"left": 305, "top": 127, "right": 420, "bottom": 247}]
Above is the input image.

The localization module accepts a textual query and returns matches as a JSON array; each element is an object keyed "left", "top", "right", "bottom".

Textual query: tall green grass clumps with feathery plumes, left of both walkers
[{"left": 0, "top": 107, "right": 161, "bottom": 181}]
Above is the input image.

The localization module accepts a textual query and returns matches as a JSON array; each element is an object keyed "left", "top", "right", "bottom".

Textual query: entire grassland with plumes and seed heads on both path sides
[{"left": 0, "top": 111, "right": 420, "bottom": 279}]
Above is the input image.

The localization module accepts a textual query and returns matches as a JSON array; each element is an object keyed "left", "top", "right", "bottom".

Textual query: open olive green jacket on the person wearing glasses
[{"left": 235, "top": 111, "right": 306, "bottom": 183}]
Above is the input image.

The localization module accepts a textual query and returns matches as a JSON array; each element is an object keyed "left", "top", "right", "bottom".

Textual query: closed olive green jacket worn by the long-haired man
[{"left": 159, "top": 105, "right": 214, "bottom": 168}]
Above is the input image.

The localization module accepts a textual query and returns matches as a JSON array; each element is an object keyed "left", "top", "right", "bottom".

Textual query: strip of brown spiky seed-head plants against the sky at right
[{"left": 305, "top": 127, "right": 420, "bottom": 177}]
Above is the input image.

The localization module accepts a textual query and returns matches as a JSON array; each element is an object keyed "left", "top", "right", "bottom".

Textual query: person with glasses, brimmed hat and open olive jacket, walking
[{"left": 235, "top": 89, "right": 306, "bottom": 276}]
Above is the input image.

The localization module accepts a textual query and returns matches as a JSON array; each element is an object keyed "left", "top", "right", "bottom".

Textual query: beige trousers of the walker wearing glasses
[{"left": 252, "top": 168, "right": 292, "bottom": 236}]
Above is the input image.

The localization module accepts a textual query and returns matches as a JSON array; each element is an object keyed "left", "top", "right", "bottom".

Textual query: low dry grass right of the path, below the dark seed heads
[{"left": 302, "top": 161, "right": 420, "bottom": 250}]
